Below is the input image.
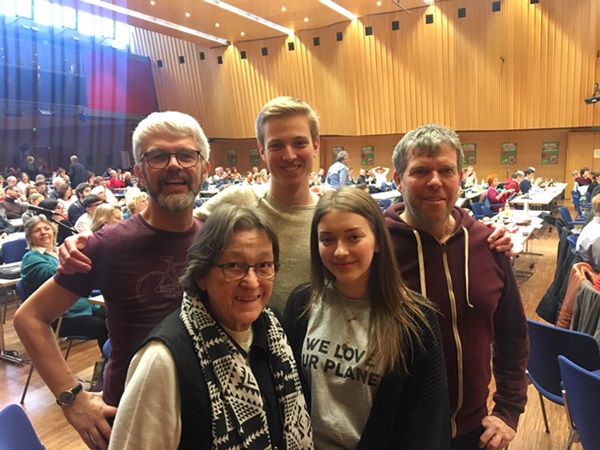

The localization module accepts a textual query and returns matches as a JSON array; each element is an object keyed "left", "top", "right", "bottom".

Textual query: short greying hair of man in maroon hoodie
[{"left": 392, "top": 123, "right": 464, "bottom": 178}]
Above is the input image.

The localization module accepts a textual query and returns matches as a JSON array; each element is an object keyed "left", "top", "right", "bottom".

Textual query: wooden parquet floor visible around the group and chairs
[{"left": 0, "top": 202, "right": 582, "bottom": 450}]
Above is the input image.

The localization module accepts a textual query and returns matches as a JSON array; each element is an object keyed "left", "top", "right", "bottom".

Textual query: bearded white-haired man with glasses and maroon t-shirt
[{"left": 14, "top": 112, "right": 210, "bottom": 449}]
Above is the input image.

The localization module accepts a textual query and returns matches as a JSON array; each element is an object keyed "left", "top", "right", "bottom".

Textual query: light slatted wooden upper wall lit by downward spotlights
[{"left": 134, "top": 0, "right": 600, "bottom": 138}]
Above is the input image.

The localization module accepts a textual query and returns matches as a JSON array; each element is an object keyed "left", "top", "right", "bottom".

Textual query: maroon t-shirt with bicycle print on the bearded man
[{"left": 54, "top": 214, "right": 202, "bottom": 406}]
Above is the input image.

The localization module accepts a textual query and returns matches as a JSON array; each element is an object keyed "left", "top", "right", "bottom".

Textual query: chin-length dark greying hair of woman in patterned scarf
[{"left": 180, "top": 204, "right": 279, "bottom": 300}]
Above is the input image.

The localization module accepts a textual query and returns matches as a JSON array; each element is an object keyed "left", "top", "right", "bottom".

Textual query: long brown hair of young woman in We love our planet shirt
[{"left": 307, "top": 187, "right": 434, "bottom": 373}]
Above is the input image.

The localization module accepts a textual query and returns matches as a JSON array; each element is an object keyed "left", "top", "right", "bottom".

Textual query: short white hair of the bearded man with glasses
[{"left": 132, "top": 111, "right": 210, "bottom": 164}]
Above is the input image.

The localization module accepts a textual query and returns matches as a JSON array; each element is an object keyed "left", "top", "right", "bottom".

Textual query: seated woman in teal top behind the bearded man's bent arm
[{"left": 21, "top": 216, "right": 108, "bottom": 350}]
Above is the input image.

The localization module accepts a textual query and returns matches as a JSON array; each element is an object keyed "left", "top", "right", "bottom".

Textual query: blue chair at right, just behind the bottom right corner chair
[{"left": 527, "top": 319, "right": 600, "bottom": 433}]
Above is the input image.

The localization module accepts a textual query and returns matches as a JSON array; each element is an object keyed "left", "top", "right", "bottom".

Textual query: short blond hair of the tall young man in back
[{"left": 256, "top": 97, "right": 319, "bottom": 146}]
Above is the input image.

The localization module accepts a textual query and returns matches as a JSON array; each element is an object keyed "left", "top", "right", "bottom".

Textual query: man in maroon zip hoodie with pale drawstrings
[{"left": 385, "top": 124, "right": 529, "bottom": 450}]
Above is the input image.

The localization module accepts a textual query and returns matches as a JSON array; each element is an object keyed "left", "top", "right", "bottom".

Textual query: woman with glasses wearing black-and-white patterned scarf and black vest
[{"left": 110, "top": 205, "right": 313, "bottom": 450}]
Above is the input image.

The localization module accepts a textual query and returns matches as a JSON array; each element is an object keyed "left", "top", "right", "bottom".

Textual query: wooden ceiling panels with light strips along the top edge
[{"left": 68, "top": 0, "right": 439, "bottom": 47}]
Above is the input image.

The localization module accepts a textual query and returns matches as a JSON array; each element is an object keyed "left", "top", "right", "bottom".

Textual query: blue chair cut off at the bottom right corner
[{"left": 558, "top": 356, "right": 600, "bottom": 450}]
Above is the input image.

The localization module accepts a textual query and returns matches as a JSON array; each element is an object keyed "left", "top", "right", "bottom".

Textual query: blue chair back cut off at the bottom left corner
[{"left": 0, "top": 404, "right": 44, "bottom": 450}]
